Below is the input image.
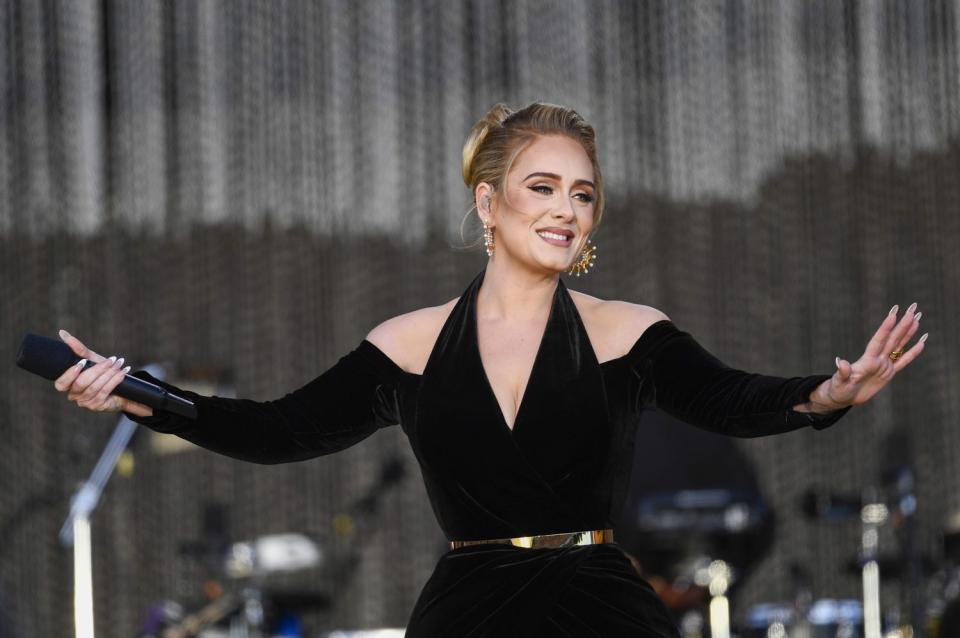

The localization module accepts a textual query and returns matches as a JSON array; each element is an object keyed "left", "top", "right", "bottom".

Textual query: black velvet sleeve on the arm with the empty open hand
[{"left": 627, "top": 319, "right": 851, "bottom": 437}]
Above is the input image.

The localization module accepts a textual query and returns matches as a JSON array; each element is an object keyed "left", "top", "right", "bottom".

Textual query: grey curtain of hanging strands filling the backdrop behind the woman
[{"left": 0, "top": 0, "right": 960, "bottom": 636}]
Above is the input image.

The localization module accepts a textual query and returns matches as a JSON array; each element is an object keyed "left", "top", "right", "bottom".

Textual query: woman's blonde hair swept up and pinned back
[{"left": 461, "top": 102, "right": 604, "bottom": 249}]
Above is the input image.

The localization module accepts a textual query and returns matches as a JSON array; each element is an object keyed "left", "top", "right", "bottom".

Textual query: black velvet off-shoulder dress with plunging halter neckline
[{"left": 128, "top": 271, "right": 850, "bottom": 638}]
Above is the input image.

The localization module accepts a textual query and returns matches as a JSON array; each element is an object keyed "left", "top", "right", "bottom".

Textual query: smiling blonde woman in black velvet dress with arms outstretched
[{"left": 55, "top": 103, "right": 926, "bottom": 637}]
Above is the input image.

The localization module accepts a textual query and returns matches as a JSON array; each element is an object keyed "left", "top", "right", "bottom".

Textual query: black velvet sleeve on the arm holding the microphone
[{"left": 124, "top": 340, "right": 401, "bottom": 463}]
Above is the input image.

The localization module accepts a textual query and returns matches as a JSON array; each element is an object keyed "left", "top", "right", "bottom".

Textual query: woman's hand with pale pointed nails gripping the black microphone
[{"left": 53, "top": 330, "right": 153, "bottom": 416}]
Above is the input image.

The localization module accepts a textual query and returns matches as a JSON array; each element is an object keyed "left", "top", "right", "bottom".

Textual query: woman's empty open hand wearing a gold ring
[{"left": 811, "top": 303, "right": 929, "bottom": 409}]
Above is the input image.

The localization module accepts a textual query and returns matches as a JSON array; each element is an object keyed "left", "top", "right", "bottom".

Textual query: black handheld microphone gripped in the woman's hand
[{"left": 17, "top": 333, "right": 197, "bottom": 419}]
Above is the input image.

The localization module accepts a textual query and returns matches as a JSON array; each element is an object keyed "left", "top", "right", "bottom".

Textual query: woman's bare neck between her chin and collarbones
[{"left": 477, "top": 258, "right": 560, "bottom": 321}]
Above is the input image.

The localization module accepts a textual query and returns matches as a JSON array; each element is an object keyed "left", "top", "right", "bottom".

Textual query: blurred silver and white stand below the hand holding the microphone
[{"left": 60, "top": 364, "right": 166, "bottom": 638}]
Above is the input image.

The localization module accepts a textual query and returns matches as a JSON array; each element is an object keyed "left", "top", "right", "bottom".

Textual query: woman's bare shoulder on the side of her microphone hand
[{"left": 366, "top": 297, "right": 459, "bottom": 374}]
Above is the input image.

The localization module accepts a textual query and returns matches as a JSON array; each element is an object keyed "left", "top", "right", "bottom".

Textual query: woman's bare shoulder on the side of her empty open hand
[{"left": 570, "top": 290, "right": 670, "bottom": 362}]
